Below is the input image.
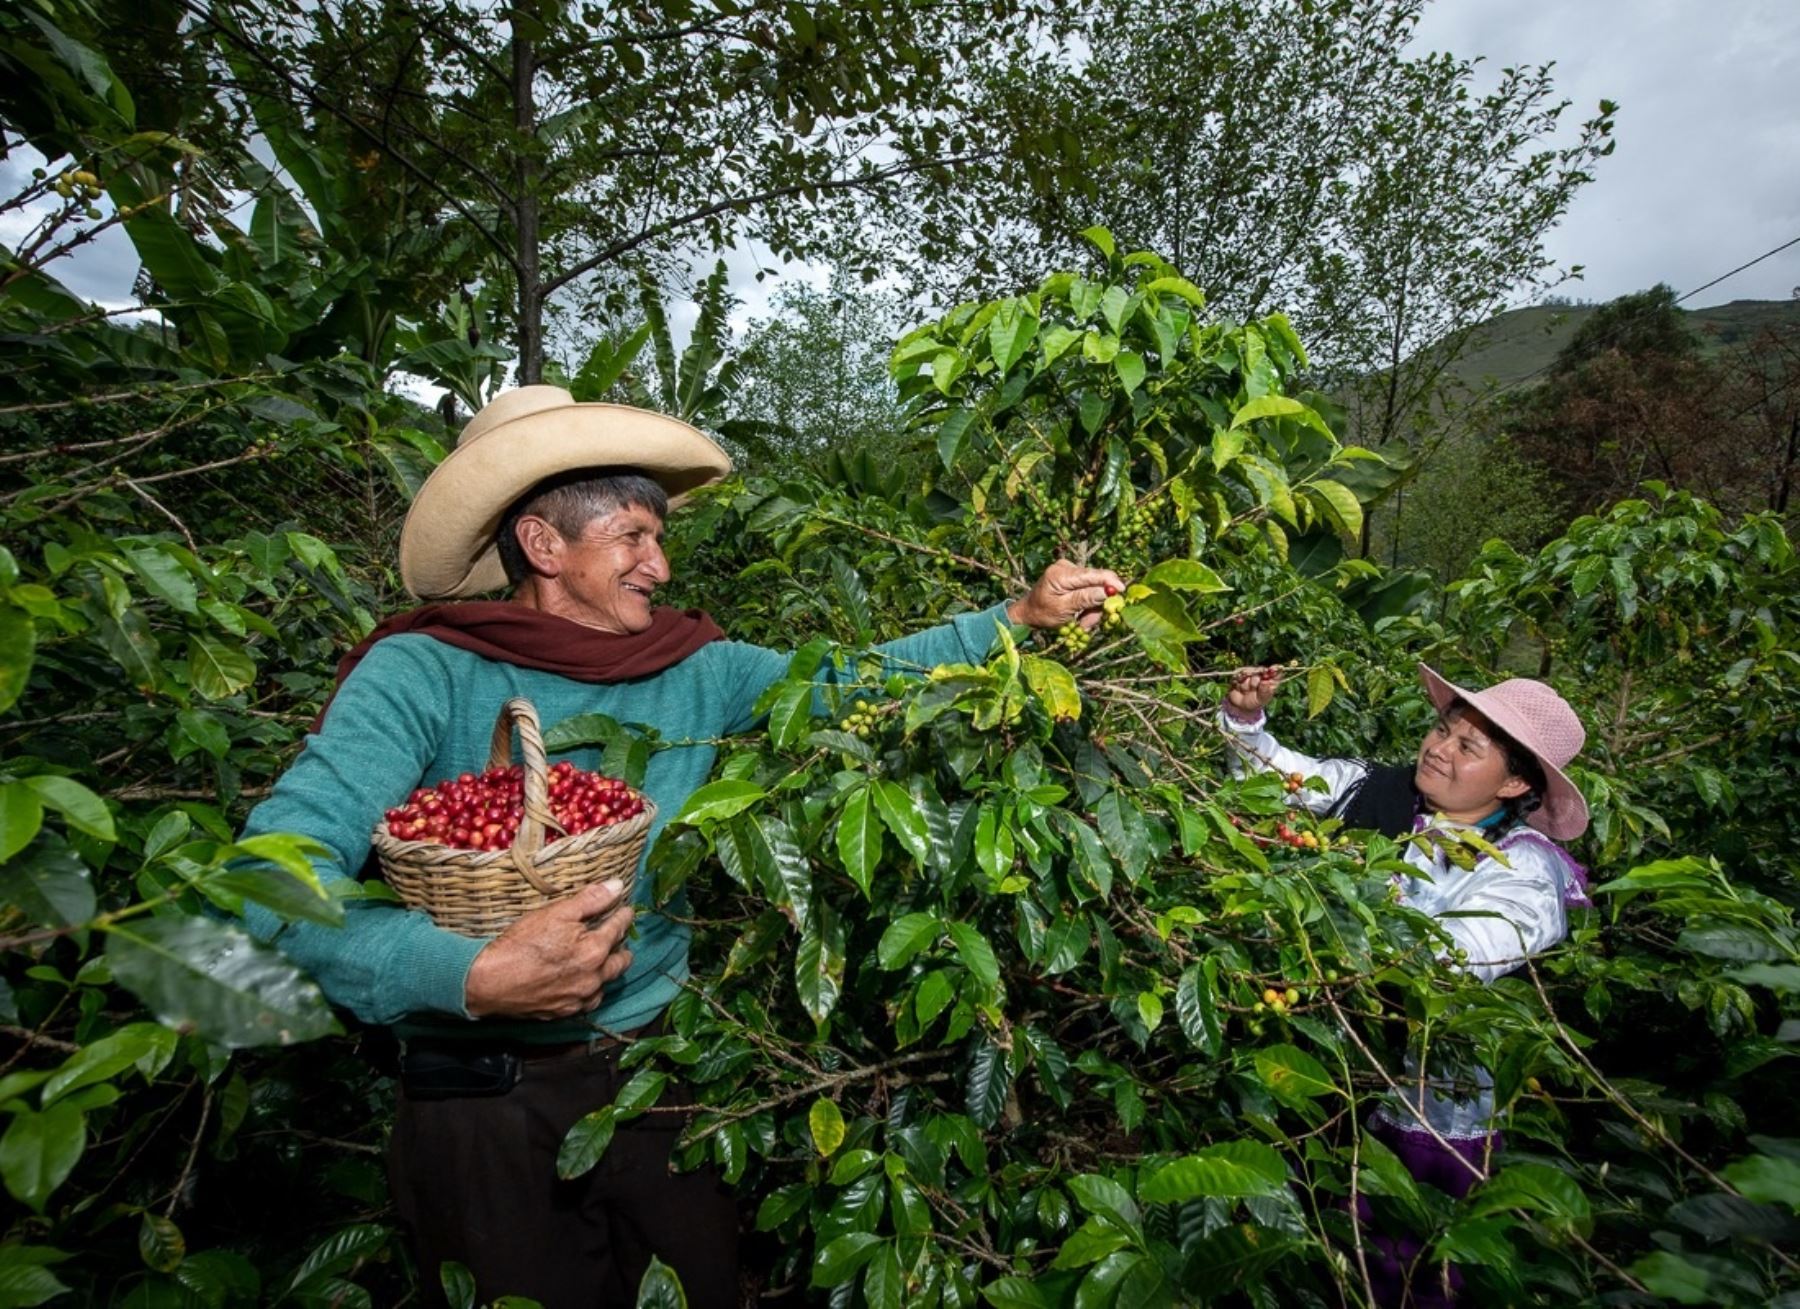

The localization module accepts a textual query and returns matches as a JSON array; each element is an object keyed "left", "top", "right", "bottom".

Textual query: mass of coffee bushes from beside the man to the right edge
[{"left": 590, "top": 241, "right": 1800, "bottom": 1305}]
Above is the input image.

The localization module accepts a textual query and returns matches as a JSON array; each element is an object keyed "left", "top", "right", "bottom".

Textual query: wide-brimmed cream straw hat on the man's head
[{"left": 400, "top": 385, "right": 731, "bottom": 600}]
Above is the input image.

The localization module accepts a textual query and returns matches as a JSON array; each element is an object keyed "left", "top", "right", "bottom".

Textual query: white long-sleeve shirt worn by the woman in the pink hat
[{"left": 1219, "top": 711, "right": 1584, "bottom": 1138}]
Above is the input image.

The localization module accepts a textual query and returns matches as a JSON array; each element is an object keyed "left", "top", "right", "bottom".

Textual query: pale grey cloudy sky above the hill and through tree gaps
[{"left": 0, "top": 0, "right": 1800, "bottom": 324}]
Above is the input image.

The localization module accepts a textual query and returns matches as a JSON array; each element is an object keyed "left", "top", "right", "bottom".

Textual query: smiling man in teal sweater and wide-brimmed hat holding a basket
[{"left": 232, "top": 385, "right": 1123, "bottom": 1309}]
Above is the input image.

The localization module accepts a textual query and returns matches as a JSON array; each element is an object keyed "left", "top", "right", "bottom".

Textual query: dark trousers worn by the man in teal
[{"left": 387, "top": 1046, "right": 738, "bottom": 1309}]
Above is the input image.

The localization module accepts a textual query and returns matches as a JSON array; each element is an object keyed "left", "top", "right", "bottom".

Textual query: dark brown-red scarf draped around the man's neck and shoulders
[{"left": 313, "top": 600, "right": 725, "bottom": 731}]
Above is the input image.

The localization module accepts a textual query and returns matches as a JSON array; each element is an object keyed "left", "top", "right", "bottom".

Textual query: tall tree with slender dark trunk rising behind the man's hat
[{"left": 197, "top": 0, "right": 1058, "bottom": 382}]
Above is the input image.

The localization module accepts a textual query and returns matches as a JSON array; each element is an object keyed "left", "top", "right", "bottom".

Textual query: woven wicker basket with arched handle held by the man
[{"left": 373, "top": 699, "right": 657, "bottom": 936}]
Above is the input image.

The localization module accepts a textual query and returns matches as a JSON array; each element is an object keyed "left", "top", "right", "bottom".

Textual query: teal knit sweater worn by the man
[{"left": 245, "top": 605, "right": 1006, "bottom": 1041}]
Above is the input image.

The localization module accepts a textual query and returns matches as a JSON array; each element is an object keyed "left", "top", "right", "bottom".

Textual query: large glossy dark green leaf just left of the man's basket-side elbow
[{"left": 106, "top": 918, "right": 338, "bottom": 1048}]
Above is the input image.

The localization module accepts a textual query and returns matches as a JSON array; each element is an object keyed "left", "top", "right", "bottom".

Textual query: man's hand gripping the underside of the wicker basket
[{"left": 463, "top": 879, "right": 632, "bottom": 1019}]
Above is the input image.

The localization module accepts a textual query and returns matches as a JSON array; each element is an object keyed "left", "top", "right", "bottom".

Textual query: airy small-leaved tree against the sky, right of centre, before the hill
[{"left": 970, "top": 0, "right": 1613, "bottom": 455}]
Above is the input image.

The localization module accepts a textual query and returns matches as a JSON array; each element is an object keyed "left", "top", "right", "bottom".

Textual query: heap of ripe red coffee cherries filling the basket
[{"left": 385, "top": 760, "right": 644, "bottom": 850}]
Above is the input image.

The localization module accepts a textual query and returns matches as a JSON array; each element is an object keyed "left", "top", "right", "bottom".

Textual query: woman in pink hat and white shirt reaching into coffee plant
[{"left": 1220, "top": 664, "right": 1588, "bottom": 1305}]
